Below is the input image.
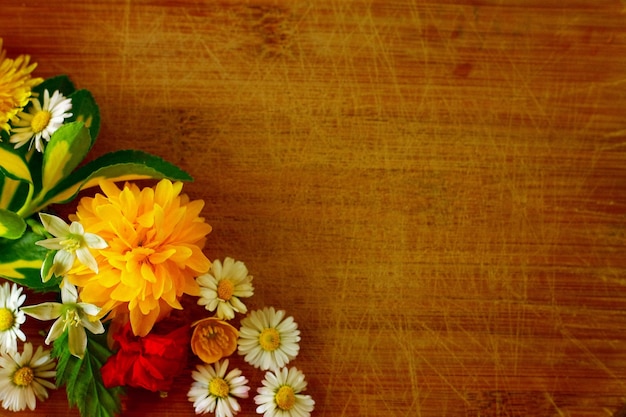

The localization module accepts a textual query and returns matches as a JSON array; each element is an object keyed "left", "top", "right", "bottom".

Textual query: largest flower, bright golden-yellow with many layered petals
[{"left": 67, "top": 180, "right": 211, "bottom": 336}]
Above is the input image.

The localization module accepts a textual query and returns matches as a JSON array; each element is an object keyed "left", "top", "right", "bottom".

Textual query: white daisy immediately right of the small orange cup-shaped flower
[{"left": 237, "top": 307, "right": 300, "bottom": 371}]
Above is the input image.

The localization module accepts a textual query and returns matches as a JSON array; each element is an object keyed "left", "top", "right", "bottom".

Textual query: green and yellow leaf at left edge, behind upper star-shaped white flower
[{"left": 0, "top": 229, "right": 59, "bottom": 291}]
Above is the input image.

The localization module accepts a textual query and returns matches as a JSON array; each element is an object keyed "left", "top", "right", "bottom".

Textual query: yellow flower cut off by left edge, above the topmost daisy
[{"left": 0, "top": 38, "right": 43, "bottom": 132}]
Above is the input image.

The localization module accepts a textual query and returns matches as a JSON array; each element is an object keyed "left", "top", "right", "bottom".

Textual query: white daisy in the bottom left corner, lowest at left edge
[{"left": 0, "top": 343, "right": 56, "bottom": 411}]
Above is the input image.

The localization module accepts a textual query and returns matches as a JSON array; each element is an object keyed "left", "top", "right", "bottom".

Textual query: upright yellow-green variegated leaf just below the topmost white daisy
[{"left": 41, "top": 122, "right": 91, "bottom": 192}]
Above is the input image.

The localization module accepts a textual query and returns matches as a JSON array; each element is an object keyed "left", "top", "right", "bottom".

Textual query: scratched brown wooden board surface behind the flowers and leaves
[{"left": 0, "top": 0, "right": 626, "bottom": 417}]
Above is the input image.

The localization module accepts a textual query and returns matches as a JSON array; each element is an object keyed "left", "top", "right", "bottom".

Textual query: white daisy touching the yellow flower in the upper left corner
[{"left": 9, "top": 90, "right": 72, "bottom": 152}]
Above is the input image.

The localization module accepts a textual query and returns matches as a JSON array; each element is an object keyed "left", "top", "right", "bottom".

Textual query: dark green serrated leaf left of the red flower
[{"left": 52, "top": 331, "right": 124, "bottom": 417}]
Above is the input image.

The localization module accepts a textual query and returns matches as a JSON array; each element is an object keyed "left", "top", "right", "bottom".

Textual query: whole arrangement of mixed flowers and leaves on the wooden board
[{"left": 0, "top": 39, "right": 314, "bottom": 417}]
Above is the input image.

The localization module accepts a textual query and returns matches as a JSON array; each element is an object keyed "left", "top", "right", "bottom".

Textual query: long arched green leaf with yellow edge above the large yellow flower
[{"left": 44, "top": 150, "right": 193, "bottom": 205}]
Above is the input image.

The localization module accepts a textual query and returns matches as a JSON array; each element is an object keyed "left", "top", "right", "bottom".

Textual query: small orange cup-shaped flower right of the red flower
[{"left": 191, "top": 317, "right": 239, "bottom": 363}]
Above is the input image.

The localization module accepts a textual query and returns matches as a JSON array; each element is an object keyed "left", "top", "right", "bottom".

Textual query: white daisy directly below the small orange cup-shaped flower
[{"left": 187, "top": 359, "right": 250, "bottom": 417}]
